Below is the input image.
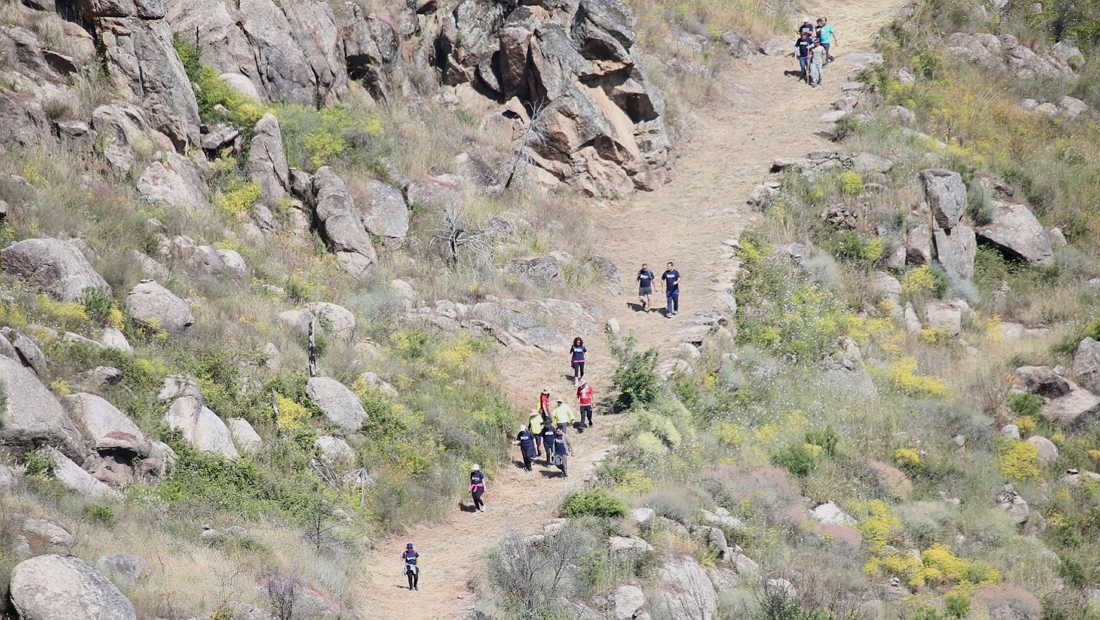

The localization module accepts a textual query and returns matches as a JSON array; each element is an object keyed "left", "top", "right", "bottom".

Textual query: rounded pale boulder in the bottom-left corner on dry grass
[{"left": 11, "top": 555, "right": 138, "bottom": 620}]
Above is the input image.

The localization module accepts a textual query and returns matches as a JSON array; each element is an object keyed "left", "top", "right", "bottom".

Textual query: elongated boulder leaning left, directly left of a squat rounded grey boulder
[{"left": 314, "top": 166, "right": 377, "bottom": 276}]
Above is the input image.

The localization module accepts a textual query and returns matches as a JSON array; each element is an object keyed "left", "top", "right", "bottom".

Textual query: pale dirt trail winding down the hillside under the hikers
[{"left": 358, "top": 0, "right": 898, "bottom": 619}]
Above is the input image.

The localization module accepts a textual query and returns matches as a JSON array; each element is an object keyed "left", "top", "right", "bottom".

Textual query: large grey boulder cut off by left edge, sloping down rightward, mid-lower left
[{"left": 0, "top": 357, "right": 85, "bottom": 457}]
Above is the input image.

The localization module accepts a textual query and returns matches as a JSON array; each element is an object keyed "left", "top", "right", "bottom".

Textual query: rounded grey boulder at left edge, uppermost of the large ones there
[{"left": 0, "top": 239, "right": 111, "bottom": 301}]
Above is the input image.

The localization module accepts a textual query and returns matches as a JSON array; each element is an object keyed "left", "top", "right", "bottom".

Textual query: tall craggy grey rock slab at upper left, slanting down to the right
[{"left": 79, "top": 0, "right": 199, "bottom": 151}]
